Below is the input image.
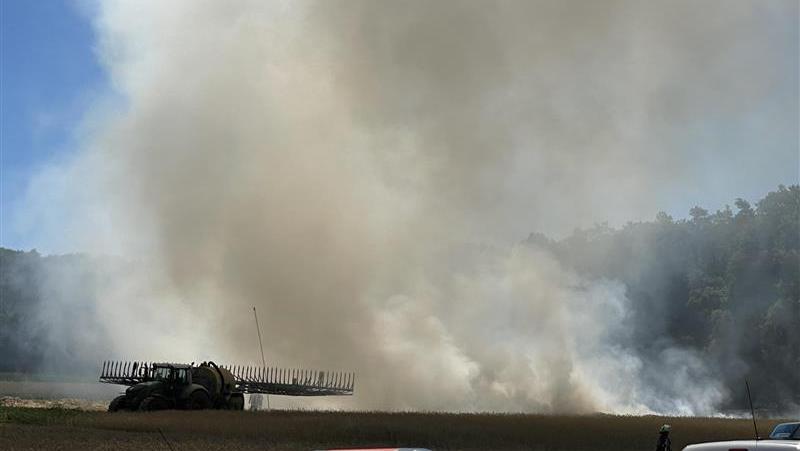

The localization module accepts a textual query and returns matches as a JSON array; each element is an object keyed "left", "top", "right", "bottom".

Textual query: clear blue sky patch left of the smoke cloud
[{"left": 0, "top": 0, "right": 106, "bottom": 251}]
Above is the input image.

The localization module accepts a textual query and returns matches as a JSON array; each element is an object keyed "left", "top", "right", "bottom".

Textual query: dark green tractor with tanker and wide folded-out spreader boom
[{"left": 100, "top": 361, "right": 355, "bottom": 412}]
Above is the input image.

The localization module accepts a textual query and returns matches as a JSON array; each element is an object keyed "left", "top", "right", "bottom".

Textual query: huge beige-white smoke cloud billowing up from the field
[{"left": 9, "top": 1, "right": 799, "bottom": 414}]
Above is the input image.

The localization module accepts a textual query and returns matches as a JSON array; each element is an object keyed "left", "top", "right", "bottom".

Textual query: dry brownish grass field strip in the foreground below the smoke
[{"left": 0, "top": 407, "right": 788, "bottom": 451}]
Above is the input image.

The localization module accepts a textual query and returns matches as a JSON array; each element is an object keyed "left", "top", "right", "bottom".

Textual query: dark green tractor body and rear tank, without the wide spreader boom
[{"left": 108, "top": 362, "right": 244, "bottom": 412}]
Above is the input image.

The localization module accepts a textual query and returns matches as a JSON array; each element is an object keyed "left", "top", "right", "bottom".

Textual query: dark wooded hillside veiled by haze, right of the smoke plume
[{"left": 528, "top": 185, "right": 800, "bottom": 414}]
